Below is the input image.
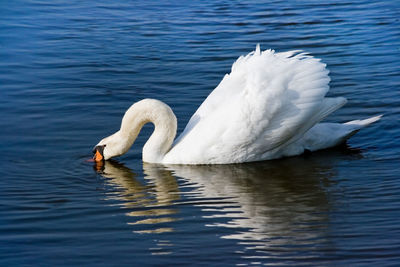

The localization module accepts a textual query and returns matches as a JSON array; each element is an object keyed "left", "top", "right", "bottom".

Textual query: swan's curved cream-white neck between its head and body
[{"left": 120, "top": 99, "right": 177, "bottom": 163}]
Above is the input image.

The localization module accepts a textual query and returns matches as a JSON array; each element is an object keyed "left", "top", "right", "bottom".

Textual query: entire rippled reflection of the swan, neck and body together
[{"left": 96, "top": 153, "right": 344, "bottom": 253}]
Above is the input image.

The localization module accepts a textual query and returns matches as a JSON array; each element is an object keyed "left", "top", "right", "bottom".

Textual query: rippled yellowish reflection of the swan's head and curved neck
[{"left": 96, "top": 161, "right": 180, "bottom": 233}]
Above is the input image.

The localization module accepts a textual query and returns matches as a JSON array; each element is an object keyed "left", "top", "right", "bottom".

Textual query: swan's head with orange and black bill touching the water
[{"left": 93, "top": 131, "right": 132, "bottom": 161}]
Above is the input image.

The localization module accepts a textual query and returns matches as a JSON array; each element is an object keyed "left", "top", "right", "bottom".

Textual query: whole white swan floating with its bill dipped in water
[{"left": 94, "top": 46, "right": 381, "bottom": 164}]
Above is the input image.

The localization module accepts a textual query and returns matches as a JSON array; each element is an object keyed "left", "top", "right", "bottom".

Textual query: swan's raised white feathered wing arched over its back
[{"left": 167, "top": 46, "right": 346, "bottom": 163}]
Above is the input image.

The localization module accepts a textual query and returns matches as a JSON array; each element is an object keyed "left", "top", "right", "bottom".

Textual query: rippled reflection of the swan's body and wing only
[{"left": 168, "top": 158, "right": 333, "bottom": 249}]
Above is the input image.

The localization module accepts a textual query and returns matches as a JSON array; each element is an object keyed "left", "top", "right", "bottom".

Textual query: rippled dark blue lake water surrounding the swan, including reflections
[{"left": 0, "top": 0, "right": 400, "bottom": 266}]
